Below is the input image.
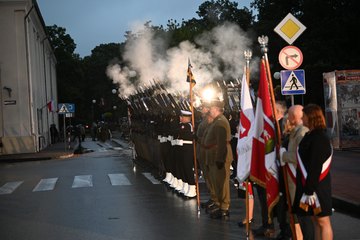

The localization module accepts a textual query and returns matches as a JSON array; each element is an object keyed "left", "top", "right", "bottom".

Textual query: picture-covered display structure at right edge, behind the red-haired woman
[{"left": 323, "top": 70, "right": 360, "bottom": 149}]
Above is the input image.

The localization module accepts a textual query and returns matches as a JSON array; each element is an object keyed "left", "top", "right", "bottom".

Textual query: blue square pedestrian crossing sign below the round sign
[{"left": 280, "top": 69, "right": 306, "bottom": 95}]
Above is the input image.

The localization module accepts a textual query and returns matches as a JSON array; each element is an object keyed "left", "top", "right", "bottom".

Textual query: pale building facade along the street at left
[{"left": 0, "top": 0, "right": 59, "bottom": 154}]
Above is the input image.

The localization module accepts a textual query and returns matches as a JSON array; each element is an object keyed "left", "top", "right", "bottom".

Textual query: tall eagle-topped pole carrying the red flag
[{"left": 258, "top": 36, "right": 297, "bottom": 240}]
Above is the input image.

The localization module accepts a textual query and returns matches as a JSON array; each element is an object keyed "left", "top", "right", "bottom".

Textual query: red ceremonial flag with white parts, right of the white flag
[{"left": 250, "top": 61, "right": 279, "bottom": 216}]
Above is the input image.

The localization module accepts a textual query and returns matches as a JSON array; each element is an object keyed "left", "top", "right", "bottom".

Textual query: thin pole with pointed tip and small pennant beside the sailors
[{"left": 187, "top": 59, "right": 200, "bottom": 215}]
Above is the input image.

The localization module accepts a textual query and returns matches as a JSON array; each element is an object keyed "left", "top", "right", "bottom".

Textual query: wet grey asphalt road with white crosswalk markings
[{"left": 0, "top": 141, "right": 360, "bottom": 240}]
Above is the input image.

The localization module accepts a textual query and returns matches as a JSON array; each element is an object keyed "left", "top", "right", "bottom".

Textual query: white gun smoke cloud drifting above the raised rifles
[{"left": 106, "top": 23, "right": 255, "bottom": 97}]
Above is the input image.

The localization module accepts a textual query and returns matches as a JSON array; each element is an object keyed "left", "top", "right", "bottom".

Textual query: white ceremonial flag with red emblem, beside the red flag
[{"left": 237, "top": 73, "right": 254, "bottom": 182}]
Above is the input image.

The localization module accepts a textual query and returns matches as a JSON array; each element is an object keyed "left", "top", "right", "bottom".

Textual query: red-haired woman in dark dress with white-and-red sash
[{"left": 293, "top": 104, "right": 333, "bottom": 240}]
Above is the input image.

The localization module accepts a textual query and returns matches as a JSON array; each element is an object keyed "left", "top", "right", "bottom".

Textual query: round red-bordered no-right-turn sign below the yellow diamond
[{"left": 279, "top": 46, "right": 303, "bottom": 70}]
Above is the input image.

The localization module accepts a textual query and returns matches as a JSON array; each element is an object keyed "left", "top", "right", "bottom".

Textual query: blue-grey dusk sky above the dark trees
[{"left": 37, "top": 0, "right": 250, "bottom": 57}]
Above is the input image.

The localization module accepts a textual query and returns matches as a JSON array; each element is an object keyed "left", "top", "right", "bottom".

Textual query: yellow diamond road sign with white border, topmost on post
[{"left": 274, "top": 13, "right": 306, "bottom": 44}]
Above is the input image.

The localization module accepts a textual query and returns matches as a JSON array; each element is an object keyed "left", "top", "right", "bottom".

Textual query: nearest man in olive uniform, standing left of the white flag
[{"left": 204, "top": 100, "right": 233, "bottom": 220}]
